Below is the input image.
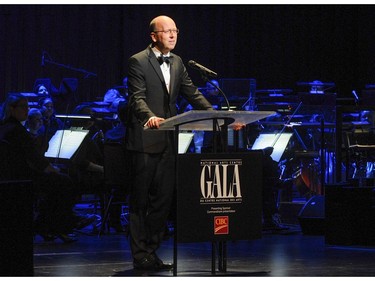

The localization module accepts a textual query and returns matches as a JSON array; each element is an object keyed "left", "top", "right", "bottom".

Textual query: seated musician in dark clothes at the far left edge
[{"left": 0, "top": 94, "right": 94, "bottom": 242}]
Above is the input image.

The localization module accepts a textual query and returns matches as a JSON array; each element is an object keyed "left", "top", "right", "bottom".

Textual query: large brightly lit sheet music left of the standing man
[{"left": 44, "top": 130, "right": 89, "bottom": 159}]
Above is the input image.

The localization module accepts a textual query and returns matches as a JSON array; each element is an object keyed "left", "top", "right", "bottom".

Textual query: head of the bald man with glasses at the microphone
[{"left": 151, "top": 18, "right": 178, "bottom": 54}]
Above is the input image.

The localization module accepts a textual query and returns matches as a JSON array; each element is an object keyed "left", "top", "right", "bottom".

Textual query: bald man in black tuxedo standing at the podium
[{"left": 127, "top": 16, "right": 212, "bottom": 271}]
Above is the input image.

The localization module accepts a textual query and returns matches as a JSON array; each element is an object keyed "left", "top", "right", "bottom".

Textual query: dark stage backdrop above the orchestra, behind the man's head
[{"left": 0, "top": 5, "right": 375, "bottom": 107}]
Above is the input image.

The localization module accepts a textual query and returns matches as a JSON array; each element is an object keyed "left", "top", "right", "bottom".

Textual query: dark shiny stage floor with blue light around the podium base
[{"left": 34, "top": 225, "right": 375, "bottom": 277}]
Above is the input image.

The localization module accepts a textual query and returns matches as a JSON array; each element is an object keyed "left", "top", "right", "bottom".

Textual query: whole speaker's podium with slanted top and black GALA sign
[{"left": 155, "top": 110, "right": 275, "bottom": 275}]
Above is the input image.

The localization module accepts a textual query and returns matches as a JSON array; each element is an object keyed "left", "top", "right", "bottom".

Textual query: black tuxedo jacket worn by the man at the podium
[{"left": 127, "top": 46, "right": 212, "bottom": 153}]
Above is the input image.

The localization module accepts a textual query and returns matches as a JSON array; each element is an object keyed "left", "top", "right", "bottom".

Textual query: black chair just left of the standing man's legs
[{"left": 99, "top": 142, "right": 129, "bottom": 236}]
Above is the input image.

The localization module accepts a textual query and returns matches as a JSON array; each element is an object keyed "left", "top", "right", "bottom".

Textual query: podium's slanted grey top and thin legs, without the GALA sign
[{"left": 155, "top": 110, "right": 276, "bottom": 276}]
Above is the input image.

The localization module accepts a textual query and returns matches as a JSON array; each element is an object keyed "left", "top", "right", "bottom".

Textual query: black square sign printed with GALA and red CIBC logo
[{"left": 177, "top": 151, "right": 262, "bottom": 242}]
